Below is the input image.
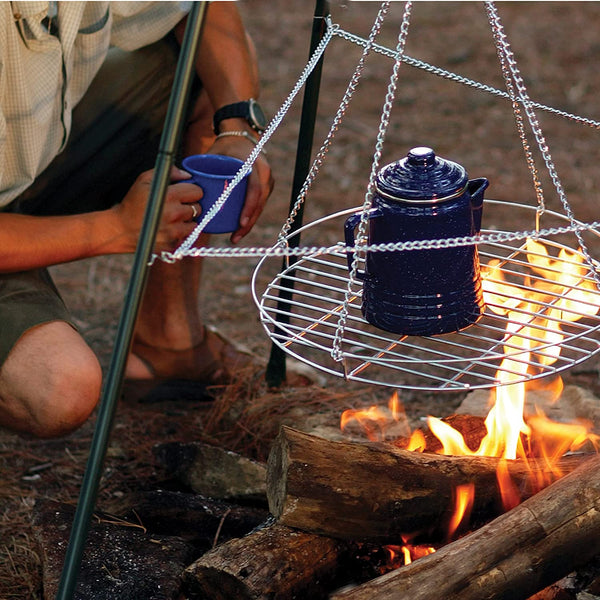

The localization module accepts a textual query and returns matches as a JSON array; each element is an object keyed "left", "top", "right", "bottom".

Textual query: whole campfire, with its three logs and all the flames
[{"left": 152, "top": 240, "right": 600, "bottom": 600}]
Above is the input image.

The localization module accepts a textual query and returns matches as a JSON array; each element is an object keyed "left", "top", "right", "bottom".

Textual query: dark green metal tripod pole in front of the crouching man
[{"left": 56, "top": 2, "right": 207, "bottom": 600}]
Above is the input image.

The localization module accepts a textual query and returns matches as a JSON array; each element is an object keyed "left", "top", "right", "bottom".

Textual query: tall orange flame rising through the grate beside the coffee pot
[{"left": 428, "top": 239, "right": 600, "bottom": 492}]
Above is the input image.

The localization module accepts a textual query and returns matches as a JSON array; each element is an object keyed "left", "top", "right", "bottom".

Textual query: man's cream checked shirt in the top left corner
[{"left": 0, "top": 1, "right": 189, "bottom": 207}]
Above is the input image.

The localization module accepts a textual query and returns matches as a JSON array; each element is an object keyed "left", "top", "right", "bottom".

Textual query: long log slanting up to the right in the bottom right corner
[{"left": 331, "top": 457, "right": 600, "bottom": 600}]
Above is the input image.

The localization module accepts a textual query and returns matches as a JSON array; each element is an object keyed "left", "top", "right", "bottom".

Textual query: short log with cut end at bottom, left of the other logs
[{"left": 184, "top": 525, "right": 349, "bottom": 600}]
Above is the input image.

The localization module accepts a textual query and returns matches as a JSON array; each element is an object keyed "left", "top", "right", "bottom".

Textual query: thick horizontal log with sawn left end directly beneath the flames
[{"left": 267, "top": 427, "right": 585, "bottom": 544}]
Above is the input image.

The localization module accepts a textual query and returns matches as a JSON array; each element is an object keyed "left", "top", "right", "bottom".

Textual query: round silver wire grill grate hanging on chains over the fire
[{"left": 253, "top": 200, "right": 600, "bottom": 390}]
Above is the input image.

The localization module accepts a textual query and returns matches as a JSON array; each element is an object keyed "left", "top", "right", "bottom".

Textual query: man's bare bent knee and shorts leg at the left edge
[{"left": 0, "top": 269, "right": 102, "bottom": 437}]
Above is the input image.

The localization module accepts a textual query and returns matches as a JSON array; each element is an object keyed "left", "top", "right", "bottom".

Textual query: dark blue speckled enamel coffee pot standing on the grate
[{"left": 345, "top": 147, "right": 489, "bottom": 336}]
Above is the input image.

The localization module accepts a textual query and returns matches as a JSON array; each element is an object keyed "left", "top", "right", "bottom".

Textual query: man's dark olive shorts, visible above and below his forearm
[{"left": 0, "top": 38, "right": 192, "bottom": 365}]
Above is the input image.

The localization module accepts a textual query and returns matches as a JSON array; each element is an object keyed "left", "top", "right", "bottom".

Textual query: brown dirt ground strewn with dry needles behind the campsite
[{"left": 0, "top": 0, "right": 600, "bottom": 600}]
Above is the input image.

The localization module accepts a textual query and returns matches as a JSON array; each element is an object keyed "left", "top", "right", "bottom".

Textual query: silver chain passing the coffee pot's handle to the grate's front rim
[{"left": 331, "top": 1, "right": 412, "bottom": 362}]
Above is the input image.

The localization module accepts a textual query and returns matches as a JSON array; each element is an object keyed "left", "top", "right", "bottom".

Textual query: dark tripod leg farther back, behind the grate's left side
[{"left": 266, "top": 0, "right": 329, "bottom": 387}]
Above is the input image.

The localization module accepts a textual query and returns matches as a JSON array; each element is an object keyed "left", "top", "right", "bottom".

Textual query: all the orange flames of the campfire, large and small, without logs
[{"left": 341, "top": 239, "right": 600, "bottom": 564}]
